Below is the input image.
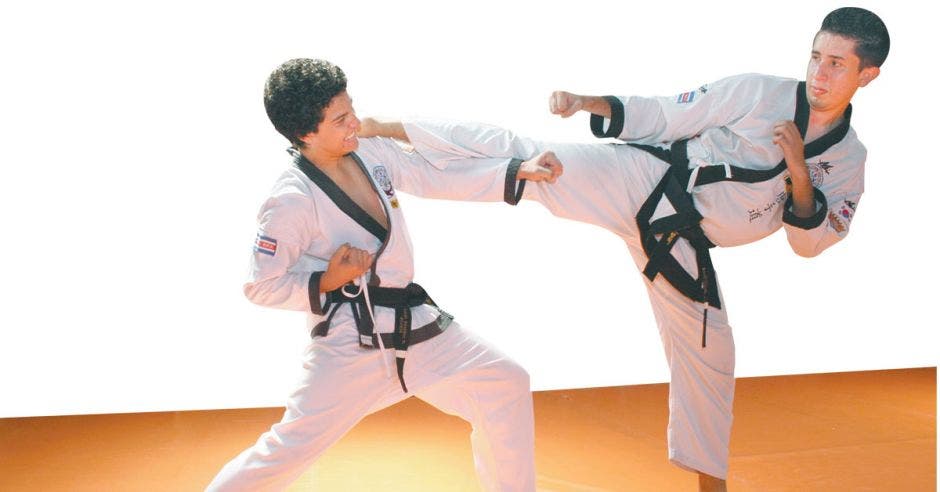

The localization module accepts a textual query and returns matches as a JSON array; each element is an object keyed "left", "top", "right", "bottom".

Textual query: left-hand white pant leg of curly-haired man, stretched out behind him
[{"left": 207, "top": 333, "right": 408, "bottom": 492}]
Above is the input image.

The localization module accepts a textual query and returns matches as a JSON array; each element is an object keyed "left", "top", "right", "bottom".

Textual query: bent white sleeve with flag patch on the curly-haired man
[{"left": 244, "top": 194, "right": 324, "bottom": 314}]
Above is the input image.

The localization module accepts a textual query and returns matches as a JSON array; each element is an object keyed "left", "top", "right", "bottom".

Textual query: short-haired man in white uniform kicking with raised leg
[{"left": 363, "top": 7, "right": 890, "bottom": 490}]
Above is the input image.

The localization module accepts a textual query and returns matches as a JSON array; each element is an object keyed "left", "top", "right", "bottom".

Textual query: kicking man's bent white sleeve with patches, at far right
[{"left": 783, "top": 152, "right": 864, "bottom": 258}]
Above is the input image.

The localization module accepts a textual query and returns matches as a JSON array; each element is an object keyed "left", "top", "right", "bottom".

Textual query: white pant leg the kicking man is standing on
[{"left": 629, "top": 239, "right": 735, "bottom": 479}]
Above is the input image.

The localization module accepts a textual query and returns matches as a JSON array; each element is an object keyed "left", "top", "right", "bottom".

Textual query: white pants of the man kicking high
[{"left": 407, "top": 121, "right": 734, "bottom": 478}]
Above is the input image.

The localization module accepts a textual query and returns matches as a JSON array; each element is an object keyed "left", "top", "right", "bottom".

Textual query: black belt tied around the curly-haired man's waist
[{"left": 310, "top": 283, "right": 453, "bottom": 393}]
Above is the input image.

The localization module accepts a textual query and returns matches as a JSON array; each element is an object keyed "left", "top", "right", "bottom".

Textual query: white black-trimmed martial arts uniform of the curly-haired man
[{"left": 209, "top": 138, "right": 535, "bottom": 491}]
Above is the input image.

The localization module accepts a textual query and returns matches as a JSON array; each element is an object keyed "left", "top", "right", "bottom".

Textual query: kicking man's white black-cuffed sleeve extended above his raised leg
[{"left": 591, "top": 75, "right": 770, "bottom": 144}]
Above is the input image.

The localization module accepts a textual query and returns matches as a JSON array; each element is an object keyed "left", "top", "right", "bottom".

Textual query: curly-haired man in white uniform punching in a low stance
[{"left": 209, "top": 59, "right": 561, "bottom": 491}]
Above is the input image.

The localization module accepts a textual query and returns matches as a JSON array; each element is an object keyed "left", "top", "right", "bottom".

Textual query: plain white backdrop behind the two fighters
[{"left": 0, "top": 1, "right": 940, "bottom": 417}]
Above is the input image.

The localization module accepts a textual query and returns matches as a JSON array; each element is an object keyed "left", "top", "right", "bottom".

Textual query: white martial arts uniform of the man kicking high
[{"left": 405, "top": 75, "right": 865, "bottom": 478}]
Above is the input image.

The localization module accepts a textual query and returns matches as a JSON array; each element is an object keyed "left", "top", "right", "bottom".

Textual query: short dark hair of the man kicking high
[{"left": 819, "top": 7, "right": 891, "bottom": 68}]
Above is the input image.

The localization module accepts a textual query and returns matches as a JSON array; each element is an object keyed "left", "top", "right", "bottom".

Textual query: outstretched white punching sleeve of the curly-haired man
[{"left": 360, "top": 132, "right": 521, "bottom": 202}]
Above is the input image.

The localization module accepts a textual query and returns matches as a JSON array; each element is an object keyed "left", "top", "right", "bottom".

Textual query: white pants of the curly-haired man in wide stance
[{"left": 207, "top": 322, "right": 535, "bottom": 491}]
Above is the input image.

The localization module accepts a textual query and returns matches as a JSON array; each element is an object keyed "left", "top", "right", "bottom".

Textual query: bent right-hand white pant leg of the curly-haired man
[{"left": 405, "top": 323, "right": 535, "bottom": 492}]
